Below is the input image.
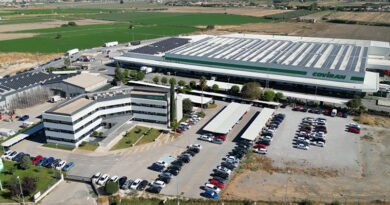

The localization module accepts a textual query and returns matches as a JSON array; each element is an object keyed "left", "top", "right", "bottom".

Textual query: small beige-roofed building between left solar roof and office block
[{"left": 45, "top": 73, "right": 107, "bottom": 98}]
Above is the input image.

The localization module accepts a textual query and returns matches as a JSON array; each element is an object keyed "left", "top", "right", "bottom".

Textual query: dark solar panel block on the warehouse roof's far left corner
[{"left": 130, "top": 38, "right": 190, "bottom": 55}]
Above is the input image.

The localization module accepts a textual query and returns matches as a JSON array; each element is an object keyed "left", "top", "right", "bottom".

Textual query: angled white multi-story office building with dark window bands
[{"left": 42, "top": 87, "right": 170, "bottom": 147}]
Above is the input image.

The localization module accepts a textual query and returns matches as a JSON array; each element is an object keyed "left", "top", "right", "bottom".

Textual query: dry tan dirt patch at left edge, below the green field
[{"left": 0, "top": 52, "right": 63, "bottom": 75}]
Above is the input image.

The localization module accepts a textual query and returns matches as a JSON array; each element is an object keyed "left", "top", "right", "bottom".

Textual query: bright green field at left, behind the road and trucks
[{"left": 0, "top": 23, "right": 199, "bottom": 53}]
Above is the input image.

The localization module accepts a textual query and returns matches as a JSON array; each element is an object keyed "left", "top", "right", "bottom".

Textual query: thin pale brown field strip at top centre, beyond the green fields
[{"left": 161, "top": 6, "right": 287, "bottom": 17}]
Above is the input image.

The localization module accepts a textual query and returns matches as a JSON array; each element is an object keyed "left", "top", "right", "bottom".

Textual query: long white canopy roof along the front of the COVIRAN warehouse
[{"left": 115, "top": 56, "right": 379, "bottom": 92}]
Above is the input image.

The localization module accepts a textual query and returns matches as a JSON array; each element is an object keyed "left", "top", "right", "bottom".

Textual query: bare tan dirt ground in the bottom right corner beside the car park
[{"left": 222, "top": 127, "right": 390, "bottom": 203}]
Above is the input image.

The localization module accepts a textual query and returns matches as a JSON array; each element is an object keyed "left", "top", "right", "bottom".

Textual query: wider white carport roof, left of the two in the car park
[{"left": 203, "top": 103, "right": 251, "bottom": 134}]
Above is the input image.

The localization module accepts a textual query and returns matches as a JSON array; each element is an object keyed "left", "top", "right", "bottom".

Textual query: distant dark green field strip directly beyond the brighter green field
[{"left": 84, "top": 12, "right": 271, "bottom": 26}]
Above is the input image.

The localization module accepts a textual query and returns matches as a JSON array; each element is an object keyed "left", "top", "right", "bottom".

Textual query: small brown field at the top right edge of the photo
[{"left": 328, "top": 12, "right": 390, "bottom": 23}]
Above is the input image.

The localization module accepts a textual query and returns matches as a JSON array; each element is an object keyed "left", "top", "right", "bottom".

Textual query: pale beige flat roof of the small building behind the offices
[{"left": 64, "top": 73, "right": 107, "bottom": 89}]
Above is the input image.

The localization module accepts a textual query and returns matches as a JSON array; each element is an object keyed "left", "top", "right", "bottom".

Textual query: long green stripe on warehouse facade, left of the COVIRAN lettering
[{"left": 165, "top": 57, "right": 307, "bottom": 75}]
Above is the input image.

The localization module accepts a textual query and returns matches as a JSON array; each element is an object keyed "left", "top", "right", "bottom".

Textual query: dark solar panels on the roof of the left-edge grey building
[{"left": 0, "top": 72, "right": 72, "bottom": 93}]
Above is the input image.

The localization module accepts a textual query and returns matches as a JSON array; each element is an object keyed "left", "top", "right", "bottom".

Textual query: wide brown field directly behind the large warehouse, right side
[{"left": 205, "top": 22, "right": 390, "bottom": 42}]
